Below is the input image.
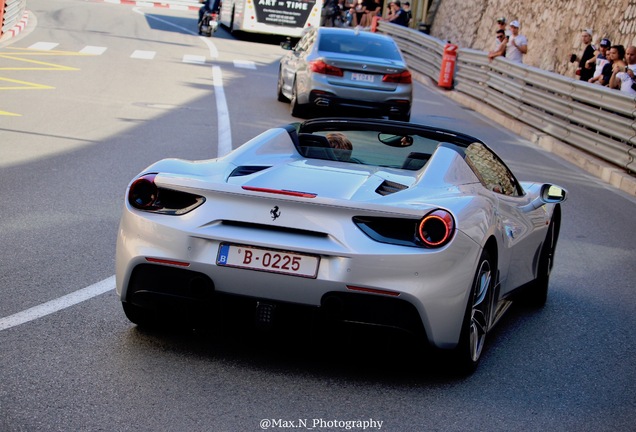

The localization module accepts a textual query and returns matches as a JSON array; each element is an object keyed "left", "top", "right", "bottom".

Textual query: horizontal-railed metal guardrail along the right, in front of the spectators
[{"left": 378, "top": 22, "right": 636, "bottom": 175}]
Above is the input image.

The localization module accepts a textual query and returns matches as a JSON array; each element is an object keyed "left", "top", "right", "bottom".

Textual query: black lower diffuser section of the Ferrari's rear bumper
[{"left": 123, "top": 264, "right": 426, "bottom": 337}]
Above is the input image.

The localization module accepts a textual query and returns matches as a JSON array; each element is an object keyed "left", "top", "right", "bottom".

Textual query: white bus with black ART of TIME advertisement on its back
[{"left": 219, "top": 0, "right": 323, "bottom": 38}]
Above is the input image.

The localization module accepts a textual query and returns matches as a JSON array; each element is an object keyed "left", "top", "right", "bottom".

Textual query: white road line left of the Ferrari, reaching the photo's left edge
[{"left": 0, "top": 276, "right": 115, "bottom": 331}]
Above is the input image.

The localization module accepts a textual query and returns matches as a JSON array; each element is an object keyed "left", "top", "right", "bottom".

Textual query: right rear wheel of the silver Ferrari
[{"left": 452, "top": 250, "right": 497, "bottom": 375}]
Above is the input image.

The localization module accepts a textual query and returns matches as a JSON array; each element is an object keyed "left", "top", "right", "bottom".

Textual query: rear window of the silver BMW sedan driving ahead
[{"left": 318, "top": 34, "right": 402, "bottom": 60}]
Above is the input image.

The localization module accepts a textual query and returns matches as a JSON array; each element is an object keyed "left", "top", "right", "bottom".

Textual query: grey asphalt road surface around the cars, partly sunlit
[{"left": 0, "top": 0, "right": 636, "bottom": 432}]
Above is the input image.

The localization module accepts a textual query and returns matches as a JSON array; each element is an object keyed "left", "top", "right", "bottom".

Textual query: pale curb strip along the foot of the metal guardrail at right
[{"left": 413, "top": 74, "right": 636, "bottom": 197}]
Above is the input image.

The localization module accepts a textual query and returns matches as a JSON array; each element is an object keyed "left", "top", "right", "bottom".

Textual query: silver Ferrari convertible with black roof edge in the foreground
[{"left": 116, "top": 118, "right": 566, "bottom": 372}]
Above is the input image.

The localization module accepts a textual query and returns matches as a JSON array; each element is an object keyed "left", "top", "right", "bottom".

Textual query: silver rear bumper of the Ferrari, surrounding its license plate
[{"left": 116, "top": 207, "right": 479, "bottom": 348}]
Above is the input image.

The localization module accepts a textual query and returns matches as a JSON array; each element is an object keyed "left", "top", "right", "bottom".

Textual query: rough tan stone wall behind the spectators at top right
[{"left": 431, "top": 0, "right": 636, "bottom": 76}]
